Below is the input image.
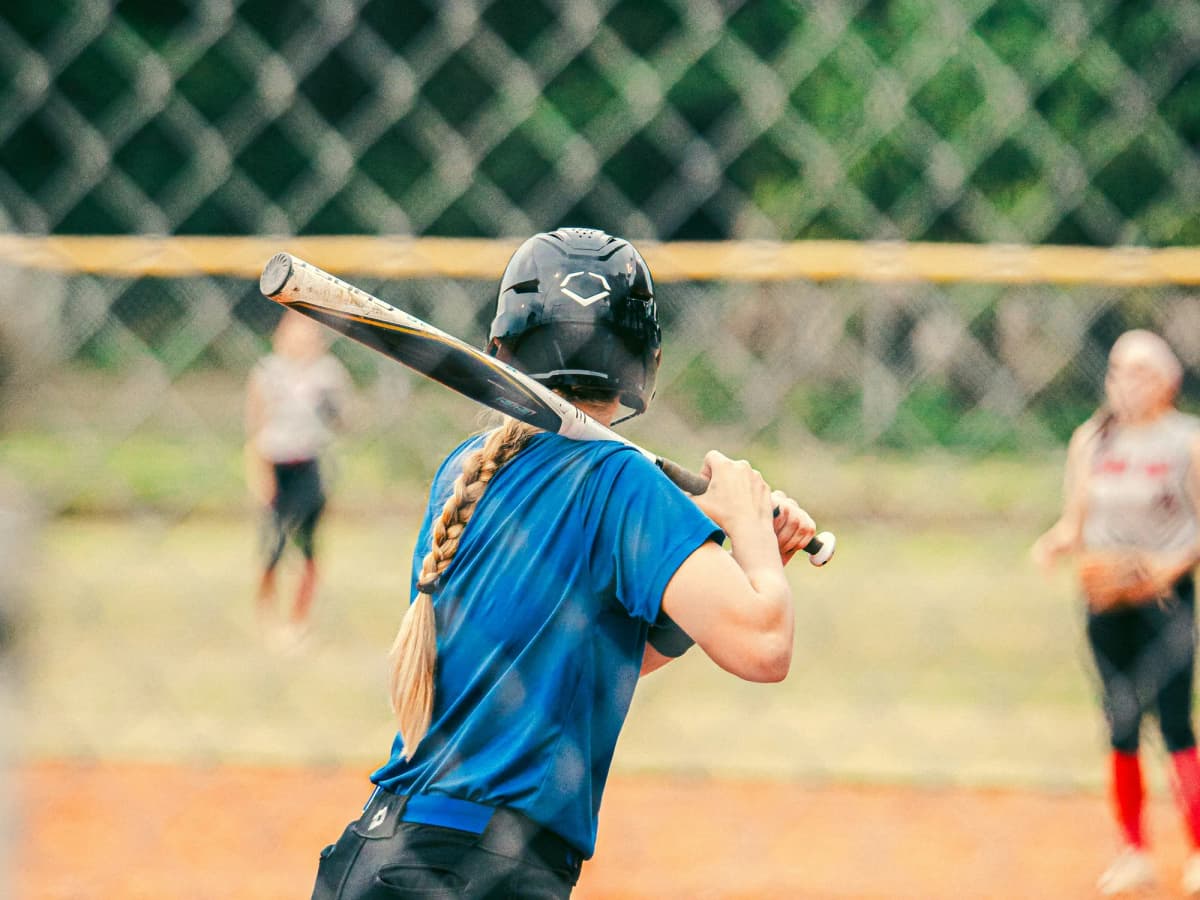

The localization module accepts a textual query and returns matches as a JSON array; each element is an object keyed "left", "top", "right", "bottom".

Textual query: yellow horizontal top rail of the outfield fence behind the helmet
[{"left": 0, "top": 234, "right": 1200, "bottom": 286}]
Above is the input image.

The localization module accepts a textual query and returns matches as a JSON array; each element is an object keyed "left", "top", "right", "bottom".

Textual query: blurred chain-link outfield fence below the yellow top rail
[{"left": 0, "top": 256, "right": 1200, "bottom": 515}]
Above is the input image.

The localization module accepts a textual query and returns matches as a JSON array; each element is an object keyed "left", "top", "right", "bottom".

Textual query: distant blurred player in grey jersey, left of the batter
[{"left": 246, "top": 312, "right": 350, "bottom": 648}]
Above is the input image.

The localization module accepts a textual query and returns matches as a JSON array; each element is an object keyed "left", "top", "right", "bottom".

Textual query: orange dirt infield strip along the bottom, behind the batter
[{"left": 14, "top": 762, "right": 1200, "bottom": 900}]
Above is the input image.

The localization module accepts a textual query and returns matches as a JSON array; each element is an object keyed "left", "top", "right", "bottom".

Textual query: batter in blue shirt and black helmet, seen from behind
[{"left": 313, "top": 228, "right": 815, "bottom": 900}]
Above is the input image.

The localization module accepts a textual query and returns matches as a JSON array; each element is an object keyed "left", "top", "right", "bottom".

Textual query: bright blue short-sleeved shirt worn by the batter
[{"left": 372, "top": 433, "right": 724, "bottom": 857}]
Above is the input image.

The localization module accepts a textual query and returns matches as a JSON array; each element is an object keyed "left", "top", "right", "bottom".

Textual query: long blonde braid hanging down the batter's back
[{"left": 389, "top": 418, "right": 536, "bottom": 760}]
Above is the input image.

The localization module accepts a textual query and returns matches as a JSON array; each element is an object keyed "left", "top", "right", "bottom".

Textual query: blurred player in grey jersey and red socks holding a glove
[{"left": 1033, "top": 331, "right": 1200, "bottom": 896}]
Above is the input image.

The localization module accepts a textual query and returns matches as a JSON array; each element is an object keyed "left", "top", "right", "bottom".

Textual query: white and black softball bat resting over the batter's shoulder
[{"left": 258, "top": 253, "right": 836, "bottom": 565}]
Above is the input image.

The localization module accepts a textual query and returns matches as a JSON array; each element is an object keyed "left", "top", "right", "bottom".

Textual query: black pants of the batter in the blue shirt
[{"left": 312, "top": 788, "right": 583, "bottom": 900}]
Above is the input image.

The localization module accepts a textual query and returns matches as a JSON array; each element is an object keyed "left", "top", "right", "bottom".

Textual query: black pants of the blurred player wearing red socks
[{"left": 1087, "top": 576, "right": 1196, "bottom": 754}]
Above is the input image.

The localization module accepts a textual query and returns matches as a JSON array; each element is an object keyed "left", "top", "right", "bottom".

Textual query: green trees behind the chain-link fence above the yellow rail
[{"left": 0, "top": 0, "right": 1200, "bottom": 246}]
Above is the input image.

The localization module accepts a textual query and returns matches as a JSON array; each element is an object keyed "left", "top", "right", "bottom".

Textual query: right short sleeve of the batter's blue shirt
[{"left": 583, "top": 451, "right": 725, "bottom": 623}]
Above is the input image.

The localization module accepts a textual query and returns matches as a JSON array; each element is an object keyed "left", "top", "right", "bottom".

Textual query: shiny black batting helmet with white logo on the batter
[{"left": 488, "top": 228, "right": 662, "bottom": 415}]
